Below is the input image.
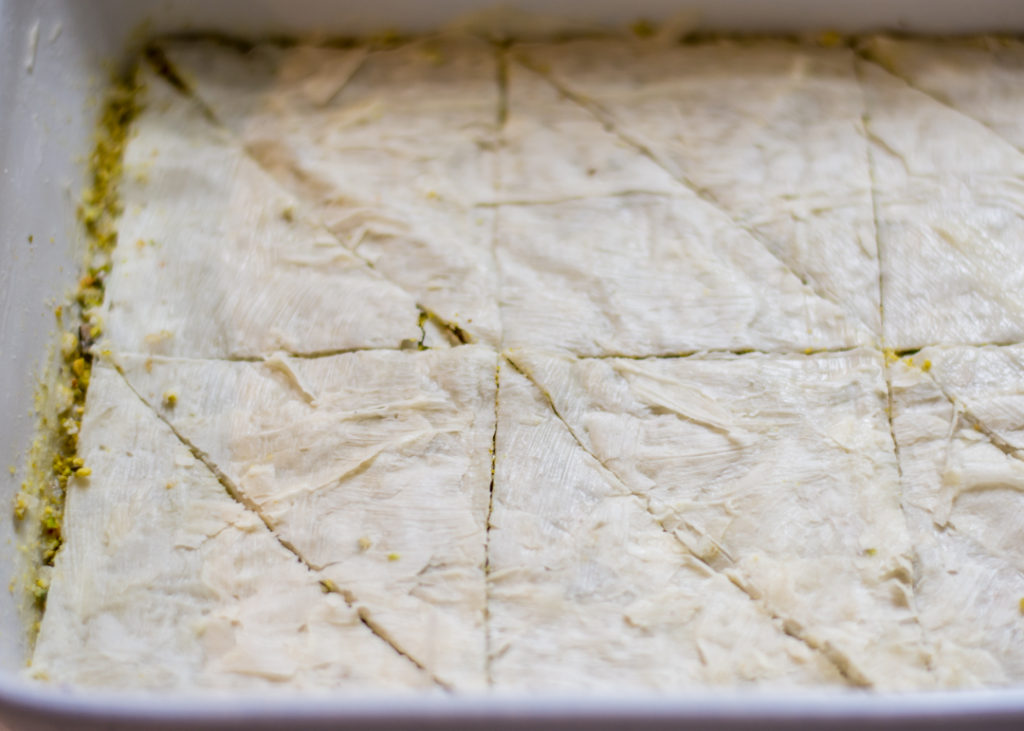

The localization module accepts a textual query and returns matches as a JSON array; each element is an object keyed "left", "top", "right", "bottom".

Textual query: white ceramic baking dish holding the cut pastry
[{"left": 6, "top": 0, "right": 1024, "bottom": 729}]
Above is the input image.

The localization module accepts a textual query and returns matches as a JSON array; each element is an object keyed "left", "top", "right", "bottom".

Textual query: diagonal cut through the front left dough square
[{"left": 110, "top": 362, "right": 452, "bottom": 691}]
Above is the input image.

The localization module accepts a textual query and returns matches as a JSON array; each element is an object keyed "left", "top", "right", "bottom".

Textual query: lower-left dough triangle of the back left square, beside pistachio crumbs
[{"left": 102, "top": 67, "right": 420, "bottom": 357}]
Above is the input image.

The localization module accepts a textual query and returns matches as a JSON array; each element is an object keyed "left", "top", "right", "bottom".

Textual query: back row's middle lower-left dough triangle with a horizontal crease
[{"left": 495, "top": 47, "right": 878, "bottom": 355}]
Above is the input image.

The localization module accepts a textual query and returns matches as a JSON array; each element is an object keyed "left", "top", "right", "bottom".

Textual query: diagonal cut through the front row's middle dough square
[{"left": 505, "top": 354, "right": 871, "bottom": 687}]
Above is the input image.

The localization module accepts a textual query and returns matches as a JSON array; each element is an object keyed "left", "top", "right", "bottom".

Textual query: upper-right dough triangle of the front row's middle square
[{"left": 510, "top": 350, "right": 931, "bottom": 688}]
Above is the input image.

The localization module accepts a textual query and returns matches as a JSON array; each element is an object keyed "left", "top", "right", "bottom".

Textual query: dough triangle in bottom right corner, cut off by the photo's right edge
[{"left": 892, "top": 360, "right": 1024, "bottom": 686}]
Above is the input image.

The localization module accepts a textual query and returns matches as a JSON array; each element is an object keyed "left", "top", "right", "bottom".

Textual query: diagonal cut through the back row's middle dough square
[{"left": 515, "top": 53, "right": 873, "bottom": 334}]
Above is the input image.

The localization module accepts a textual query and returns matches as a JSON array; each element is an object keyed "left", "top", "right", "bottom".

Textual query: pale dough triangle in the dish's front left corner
[{"left": 32, "top": 363, "right": 430, "bottom": 691}]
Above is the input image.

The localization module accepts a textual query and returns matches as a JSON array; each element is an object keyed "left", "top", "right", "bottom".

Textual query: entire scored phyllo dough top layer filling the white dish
[{"left": 30, "top": 34, "right": 1024, "bottom": 692}]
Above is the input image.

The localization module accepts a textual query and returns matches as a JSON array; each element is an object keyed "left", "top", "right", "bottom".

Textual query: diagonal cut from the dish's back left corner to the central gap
[{"left": 143, "top": 46, "right": 476, "bottom": 343}]
